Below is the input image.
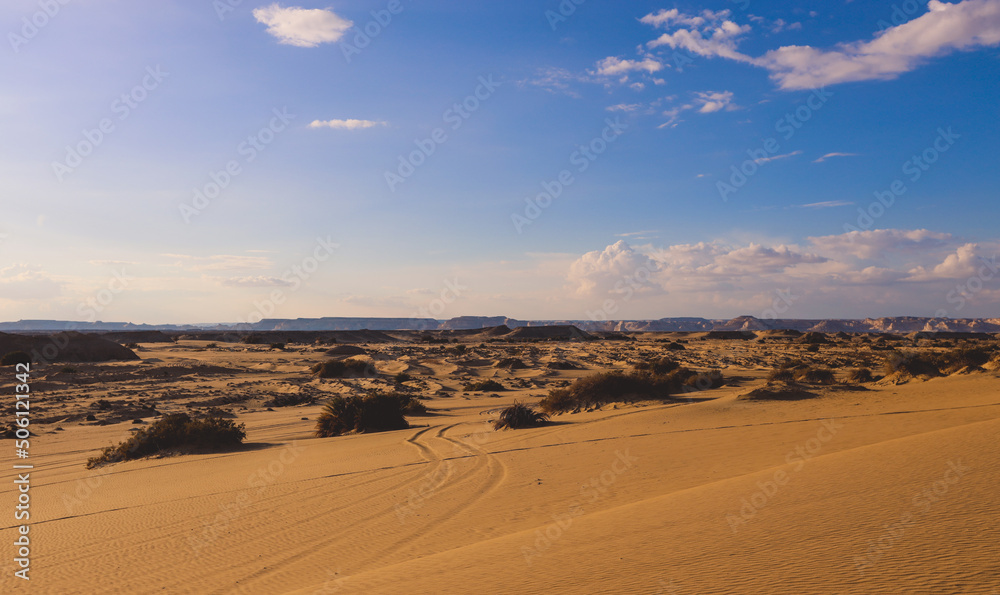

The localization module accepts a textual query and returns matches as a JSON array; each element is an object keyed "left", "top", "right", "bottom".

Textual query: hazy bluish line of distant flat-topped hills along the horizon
[{"left": 0, "top": 316, "right": 1000, "bottom": 333}]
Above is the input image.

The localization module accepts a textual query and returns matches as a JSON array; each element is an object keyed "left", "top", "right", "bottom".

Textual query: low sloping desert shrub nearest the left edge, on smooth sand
[{"left": 87, "top": 413, "right": 247, "bottom": 469}]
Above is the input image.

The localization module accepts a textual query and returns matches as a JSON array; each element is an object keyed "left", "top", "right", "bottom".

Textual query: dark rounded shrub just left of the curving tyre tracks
[{"left": 316, "top": 393, "right": 410, "bottom": 438}]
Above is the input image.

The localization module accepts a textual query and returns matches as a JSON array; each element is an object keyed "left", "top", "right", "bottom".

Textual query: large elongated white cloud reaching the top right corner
[{"left": 752, "top": 0, "right": 1000, "bottom": 90}]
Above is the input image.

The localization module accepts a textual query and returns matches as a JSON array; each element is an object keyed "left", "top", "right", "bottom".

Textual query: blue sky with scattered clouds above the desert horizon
[{"left": 0, "top": 0, "right": 1000, "bottom": 323}]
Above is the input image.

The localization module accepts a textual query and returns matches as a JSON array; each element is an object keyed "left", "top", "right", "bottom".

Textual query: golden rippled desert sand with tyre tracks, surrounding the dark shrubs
[{"left": 0, "top": 338, "right": 1000, "bottom": 595}]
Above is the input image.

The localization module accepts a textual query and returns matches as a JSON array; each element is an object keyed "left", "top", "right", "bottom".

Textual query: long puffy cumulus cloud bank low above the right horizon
[{"left": 566, "top": 229, "right": 1000, "bottom": 319}]
